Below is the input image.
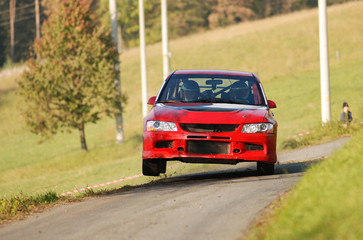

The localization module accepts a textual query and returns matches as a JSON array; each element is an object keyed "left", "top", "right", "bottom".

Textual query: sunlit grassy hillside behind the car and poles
[{"left": 0, "top": 1, "right": 363, "bottom": 196}]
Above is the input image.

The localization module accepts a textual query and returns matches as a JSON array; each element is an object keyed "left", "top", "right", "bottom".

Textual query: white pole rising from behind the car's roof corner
[{"left": 161, "top": 0, "right": 170, "bottom": 79}]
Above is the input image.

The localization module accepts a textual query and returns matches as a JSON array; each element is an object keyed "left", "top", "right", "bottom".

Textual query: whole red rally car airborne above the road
[{"left": 142, "top": 70, "right": 277, "bottom": 176}]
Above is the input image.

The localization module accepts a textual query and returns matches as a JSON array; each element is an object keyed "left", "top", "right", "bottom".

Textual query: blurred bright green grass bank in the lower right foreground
[{"left": 247, "top": 126, "right": 363, "bottom": 240}]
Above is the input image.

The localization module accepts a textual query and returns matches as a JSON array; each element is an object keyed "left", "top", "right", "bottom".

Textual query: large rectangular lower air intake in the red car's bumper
[{"left": 187, "top": 141, "right": 230, "bottom": 155}]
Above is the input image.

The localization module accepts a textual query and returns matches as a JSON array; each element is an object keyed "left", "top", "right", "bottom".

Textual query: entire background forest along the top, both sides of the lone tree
[{"left": 0, "top": 0, "right": 352, "bottom": 67}]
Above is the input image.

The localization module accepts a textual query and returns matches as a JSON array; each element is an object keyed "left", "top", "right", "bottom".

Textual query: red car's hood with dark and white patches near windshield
[{"left": 145, "top": 103, "right": 268, "bottom": 124}]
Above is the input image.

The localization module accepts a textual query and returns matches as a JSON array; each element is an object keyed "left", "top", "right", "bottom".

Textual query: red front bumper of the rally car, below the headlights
[{"left": 142, "top": 127, "right": 277, "bottom": 164}]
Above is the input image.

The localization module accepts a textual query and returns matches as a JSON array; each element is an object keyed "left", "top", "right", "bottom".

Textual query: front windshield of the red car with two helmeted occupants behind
[{"left": 158, "top": 74, "right": 266, "bottom": 105}]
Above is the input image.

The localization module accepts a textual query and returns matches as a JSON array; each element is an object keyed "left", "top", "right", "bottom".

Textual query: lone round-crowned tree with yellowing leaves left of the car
[{"left": 19, "top": 0, "right": 121, "bottom": 151}]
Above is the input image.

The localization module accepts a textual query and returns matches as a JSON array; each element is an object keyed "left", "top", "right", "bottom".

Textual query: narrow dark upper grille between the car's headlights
[{"left": 180, "top": 123, "right": 238, "bottom": 132}]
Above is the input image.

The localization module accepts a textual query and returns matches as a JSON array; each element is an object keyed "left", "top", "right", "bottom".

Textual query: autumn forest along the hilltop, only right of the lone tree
[{"left": 97, "top": 0, "right": 350, "bottom": 47}]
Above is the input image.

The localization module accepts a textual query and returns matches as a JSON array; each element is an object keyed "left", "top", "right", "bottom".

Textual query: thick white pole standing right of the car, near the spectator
[{"left": 319, "top": 0, "right": 331, "bottom": 123}]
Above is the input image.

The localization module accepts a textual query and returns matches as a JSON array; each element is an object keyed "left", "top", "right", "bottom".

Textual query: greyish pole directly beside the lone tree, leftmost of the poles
[{"left": 109, "top": 0, "right": 124, "bottom": 144}]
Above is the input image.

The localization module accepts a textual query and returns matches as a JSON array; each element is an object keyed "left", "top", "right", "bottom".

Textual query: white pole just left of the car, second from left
[{"left": 139, "top": 0, "right": 147, "bottom": 117}]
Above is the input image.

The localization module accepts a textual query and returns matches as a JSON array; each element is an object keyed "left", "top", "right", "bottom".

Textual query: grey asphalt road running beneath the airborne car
[{"left": 0, "top": 139, "right": 348, "bottom": 240}]
